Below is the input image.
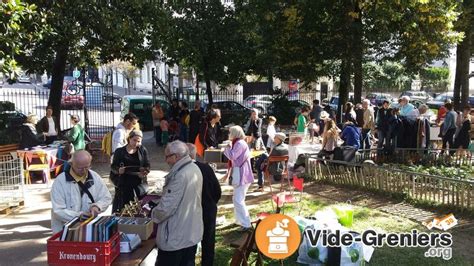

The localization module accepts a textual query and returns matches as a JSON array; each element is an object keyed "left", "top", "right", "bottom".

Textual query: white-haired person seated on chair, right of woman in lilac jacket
[{"left": 255, "top": 132, "right": 288, "bottom": 192}]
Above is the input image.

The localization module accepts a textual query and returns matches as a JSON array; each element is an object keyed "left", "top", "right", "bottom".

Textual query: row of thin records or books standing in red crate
[{"left": 60, "top": 216, "right": 118, "bottom": 242}]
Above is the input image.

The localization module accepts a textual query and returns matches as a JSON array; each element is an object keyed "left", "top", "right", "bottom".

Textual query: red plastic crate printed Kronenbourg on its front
[{"left": 47, "top": 231, "right": 120, "bottom": 265}]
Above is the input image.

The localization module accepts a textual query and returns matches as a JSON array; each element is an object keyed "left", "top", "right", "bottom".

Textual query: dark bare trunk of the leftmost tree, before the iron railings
[{"left": 48, "top": 47, "right": 68, "bottom": 130}]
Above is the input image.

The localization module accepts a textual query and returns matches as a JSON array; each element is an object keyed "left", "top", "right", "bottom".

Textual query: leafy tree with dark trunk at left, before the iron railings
[{"left": 18, "top": 0, "right": 166, "bottom": 125}]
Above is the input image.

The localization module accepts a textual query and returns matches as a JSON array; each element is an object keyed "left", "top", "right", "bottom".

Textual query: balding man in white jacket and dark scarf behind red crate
[{"left": 51, "top": 150, "right": 112, "bottom": 234}]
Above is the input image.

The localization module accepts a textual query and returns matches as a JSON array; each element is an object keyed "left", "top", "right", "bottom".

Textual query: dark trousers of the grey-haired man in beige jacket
[{"left": 155, "top": 245, "right": 197, "bottom": 266}]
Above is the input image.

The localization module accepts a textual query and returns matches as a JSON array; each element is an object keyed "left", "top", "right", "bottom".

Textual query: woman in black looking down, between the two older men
[{"left": 110, "top": 131, "right": 150, "bottom": 213}]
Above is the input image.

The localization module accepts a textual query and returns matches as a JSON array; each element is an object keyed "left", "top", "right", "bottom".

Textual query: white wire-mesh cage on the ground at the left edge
[{"left": 0, "top": 153, "right": 25, "bottom": 213}]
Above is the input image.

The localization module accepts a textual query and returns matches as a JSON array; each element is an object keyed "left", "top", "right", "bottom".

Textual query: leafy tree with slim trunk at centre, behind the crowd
[{"left": 157, "top": 0, "right": 243, "bottom": 103}]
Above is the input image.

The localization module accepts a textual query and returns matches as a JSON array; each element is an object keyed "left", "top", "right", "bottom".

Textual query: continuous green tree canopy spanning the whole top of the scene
[{"left": 0, "top": 0, "right": 466, "bottom": 112}]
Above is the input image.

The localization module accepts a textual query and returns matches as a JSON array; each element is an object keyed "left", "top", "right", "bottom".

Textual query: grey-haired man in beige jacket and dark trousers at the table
[{"left": 151, "top": 140, "right": 204, "bottom": 265}]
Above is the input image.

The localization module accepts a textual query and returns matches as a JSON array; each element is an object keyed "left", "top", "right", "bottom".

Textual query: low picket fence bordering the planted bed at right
[{"left": 306, "top": 157, "right": 474, "bottom": 210}]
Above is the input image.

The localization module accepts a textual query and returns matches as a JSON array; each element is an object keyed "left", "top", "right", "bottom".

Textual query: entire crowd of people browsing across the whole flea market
[{"left": 47, "top": 94, "right": 471, "bottom": 265}]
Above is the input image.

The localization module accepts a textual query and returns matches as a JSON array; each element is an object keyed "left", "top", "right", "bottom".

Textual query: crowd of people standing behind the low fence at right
[{"left": 295, "top": 96, "right": 472, "bottom": 157}]
